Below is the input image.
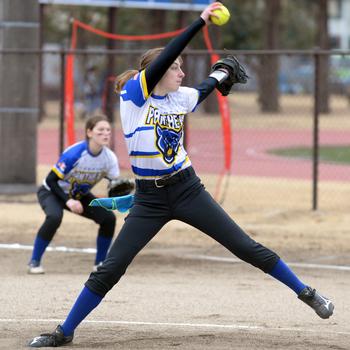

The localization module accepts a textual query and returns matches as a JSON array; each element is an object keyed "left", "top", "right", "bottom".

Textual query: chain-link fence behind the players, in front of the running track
[{"left": 0, "top": 50, "right": 350, "bottom": 209}]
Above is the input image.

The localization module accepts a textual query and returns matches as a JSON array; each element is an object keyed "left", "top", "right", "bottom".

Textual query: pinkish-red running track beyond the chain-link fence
[{"left": 38, "top": 129, "right": 350, "bottom": 181}]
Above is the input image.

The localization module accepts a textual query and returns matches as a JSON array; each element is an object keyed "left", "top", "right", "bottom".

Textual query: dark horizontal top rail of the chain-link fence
[{"left": 0, "top": 48, "right": 350, "bottom": 56}]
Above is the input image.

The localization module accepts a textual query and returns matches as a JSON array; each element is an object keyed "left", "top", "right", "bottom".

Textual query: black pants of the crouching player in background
[{"left": 37, "top": 186, "right": 116, "bottom": 241}]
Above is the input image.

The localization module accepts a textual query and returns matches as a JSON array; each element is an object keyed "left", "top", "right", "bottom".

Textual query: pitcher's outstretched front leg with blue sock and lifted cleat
[{"left": 176, "top": 189, "right": 334, "bottom": 319}]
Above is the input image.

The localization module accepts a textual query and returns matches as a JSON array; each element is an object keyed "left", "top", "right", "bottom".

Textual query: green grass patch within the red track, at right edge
[{"left": 268, "top": 145, "right": 350, "bottom": 164}]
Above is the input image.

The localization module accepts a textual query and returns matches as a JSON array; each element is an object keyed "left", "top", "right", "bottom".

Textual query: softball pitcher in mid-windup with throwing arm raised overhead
[{"left": 30, "top": 2, "right": 334, "bottom": 347}]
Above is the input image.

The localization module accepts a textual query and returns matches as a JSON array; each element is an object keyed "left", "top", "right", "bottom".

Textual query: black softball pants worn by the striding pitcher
[{"left": 85, "top": 168, "right": 279, "bottom": 297}]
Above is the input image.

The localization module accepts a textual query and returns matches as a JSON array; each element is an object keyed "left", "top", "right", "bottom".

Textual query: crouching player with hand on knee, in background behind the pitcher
[{"left": 28, "top": 115, "right": 119, "bottom": 274}]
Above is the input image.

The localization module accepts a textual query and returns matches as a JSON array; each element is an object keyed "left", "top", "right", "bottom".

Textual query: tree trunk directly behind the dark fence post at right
[{"left": 317, "top": 0, "right": 329, "bottom": 113}]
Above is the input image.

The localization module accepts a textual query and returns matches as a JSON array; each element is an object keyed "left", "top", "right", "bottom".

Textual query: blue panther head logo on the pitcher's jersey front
[{"left": 156, "top": 125, "right": 182, "bottom": 164}]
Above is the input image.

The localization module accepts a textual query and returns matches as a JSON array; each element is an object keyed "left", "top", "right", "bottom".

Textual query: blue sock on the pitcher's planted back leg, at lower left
[{"left": 61, "top": 287, "right": 103, "bottom": 337}]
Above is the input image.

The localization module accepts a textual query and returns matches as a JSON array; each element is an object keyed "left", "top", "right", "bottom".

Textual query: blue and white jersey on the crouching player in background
[{"left": 44, "top": 141, "right": 120, "bottom": 199}]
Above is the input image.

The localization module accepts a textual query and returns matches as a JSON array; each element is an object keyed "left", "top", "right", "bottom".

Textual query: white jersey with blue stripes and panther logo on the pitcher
[{"left": 120, "top": 71, "right": 199, "bottom": 179}]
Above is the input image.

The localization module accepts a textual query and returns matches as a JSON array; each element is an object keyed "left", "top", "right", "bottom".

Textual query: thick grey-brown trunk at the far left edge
[{"left": 0, "top": 0, "right": 39, "bottom": 193}]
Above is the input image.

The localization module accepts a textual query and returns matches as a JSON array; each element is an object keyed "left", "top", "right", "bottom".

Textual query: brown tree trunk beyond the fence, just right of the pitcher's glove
[{"left": 258, "top": 0, "right": 281, "bottom": 112}]
